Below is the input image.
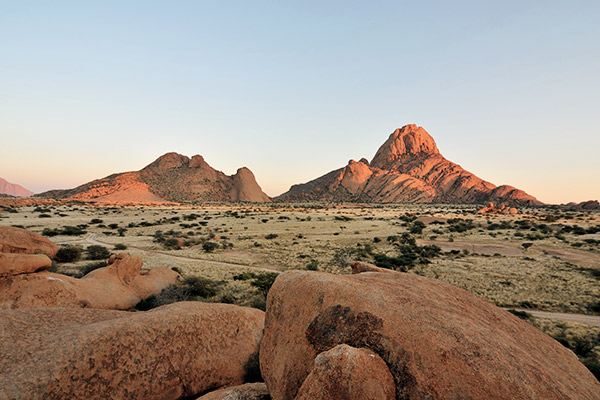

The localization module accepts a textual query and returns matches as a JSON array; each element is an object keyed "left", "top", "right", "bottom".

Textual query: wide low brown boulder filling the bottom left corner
[{"left": 0, "top": 302, "right": 264, "bottom": 400}]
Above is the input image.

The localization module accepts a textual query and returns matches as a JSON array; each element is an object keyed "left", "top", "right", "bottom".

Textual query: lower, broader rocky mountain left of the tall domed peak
[{"left": 39, "top": 153, "right": 270, "bottom": 202}]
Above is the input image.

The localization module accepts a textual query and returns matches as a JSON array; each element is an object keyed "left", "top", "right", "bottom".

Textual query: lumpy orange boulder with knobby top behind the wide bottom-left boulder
[{"left": 0, "top": 253, "right": 180, "bottom": 310}]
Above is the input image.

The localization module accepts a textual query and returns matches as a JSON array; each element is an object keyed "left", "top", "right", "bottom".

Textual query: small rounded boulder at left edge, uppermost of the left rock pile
[{"left": 0, "top": 226, "right": 58, "bottom": 258}]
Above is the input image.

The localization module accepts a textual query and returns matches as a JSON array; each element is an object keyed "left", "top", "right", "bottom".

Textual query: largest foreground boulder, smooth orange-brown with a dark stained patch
[{"left": 260, "top": 271, "right": 600, "bottom": 400}]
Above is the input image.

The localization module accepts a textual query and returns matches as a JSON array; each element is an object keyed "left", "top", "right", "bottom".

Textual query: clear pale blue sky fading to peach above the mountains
[{"left": 0, "top": 0, "right": 600, "bottom": 203}]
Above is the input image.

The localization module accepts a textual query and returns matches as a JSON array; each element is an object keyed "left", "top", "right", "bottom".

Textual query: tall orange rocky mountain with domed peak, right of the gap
[{"left": 277, "top": 125, "right": 543, "bottom": 206}]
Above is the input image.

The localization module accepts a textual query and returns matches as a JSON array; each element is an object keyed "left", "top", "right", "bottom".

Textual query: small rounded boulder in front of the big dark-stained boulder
[{"left": 295, "top": 344, "right": 396, "bottom": 400}]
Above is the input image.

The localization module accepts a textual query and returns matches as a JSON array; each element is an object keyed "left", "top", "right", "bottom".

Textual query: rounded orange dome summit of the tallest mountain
[{"left": 371, "top": 124, "right": 440, "bottom": 170}]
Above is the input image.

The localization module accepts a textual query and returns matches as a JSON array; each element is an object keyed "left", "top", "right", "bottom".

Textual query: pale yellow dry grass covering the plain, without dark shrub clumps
[{"left": 0, "top": 203, "right": 600, "bottom": 313}]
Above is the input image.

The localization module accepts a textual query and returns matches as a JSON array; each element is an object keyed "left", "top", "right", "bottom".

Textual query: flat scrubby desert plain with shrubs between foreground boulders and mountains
[{"left": 0, "top": 200, "right": 600, "bottom": 373}]
